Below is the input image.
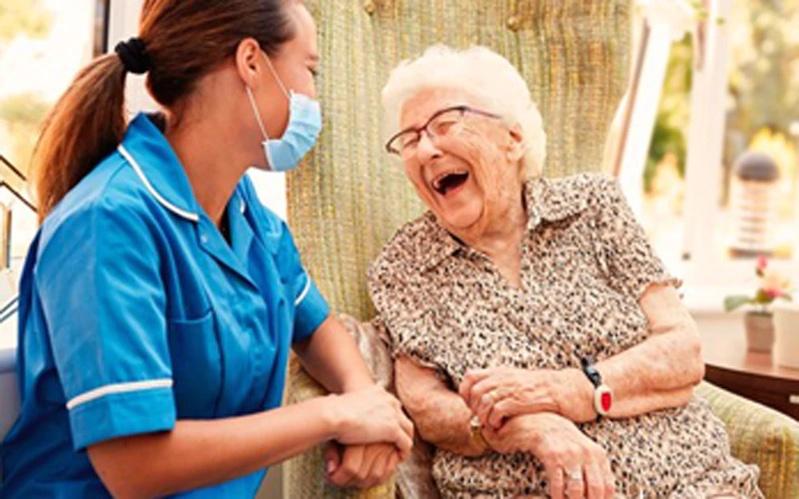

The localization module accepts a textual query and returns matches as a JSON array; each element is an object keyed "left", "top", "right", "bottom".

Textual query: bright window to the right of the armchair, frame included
[{"left": 622, "top": 0, "right": 799, "bottom": 300}]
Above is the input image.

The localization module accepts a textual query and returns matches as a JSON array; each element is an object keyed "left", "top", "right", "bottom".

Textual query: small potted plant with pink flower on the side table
[{"left": 724, "top": 256, "right": 791, "bottom": 352}]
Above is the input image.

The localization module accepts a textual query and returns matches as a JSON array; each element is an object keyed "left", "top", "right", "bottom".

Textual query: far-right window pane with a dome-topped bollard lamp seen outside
[{"left": 714, "top": 0, "right": 799, "bottom": 261}]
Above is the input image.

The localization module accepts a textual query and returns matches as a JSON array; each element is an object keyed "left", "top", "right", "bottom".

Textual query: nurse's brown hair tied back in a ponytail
[{"left": 33, "top": 0, "right": 294, "bottom": 221}]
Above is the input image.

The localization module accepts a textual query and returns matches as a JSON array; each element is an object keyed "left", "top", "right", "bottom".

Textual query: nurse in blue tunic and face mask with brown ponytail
[{"left": 0, "top": 0, "right": 413, "bottom": 498}]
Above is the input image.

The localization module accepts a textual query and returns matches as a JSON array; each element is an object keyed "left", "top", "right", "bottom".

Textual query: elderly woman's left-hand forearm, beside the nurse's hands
[{"left": 394, "top": 357, "right": 488, "bottom": 456}]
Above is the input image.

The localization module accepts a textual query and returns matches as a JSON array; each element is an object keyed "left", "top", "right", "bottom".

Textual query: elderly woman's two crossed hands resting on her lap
[{"left": 458, "top": 367, "right": 615, "bottom": 499}]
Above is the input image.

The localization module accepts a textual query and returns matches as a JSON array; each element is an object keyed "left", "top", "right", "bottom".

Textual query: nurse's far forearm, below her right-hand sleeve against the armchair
[{"left": 294, "top": 315, "right": 374, "bottom": 393}]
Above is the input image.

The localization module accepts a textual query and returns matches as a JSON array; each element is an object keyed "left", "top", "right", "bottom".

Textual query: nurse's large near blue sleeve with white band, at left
[{"left": 34, "top": 201, "right": 176, "bottom": 450}]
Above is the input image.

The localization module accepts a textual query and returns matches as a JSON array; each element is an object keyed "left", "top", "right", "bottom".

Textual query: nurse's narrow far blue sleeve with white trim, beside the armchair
[{"left": 278, "top": 223, "right": 330, "bottom": 343}]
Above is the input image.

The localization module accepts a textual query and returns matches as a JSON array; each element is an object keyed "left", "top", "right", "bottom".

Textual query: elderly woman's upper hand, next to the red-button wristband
[{"left": 458, "top": 367, "right": 596, "bottom": 429}]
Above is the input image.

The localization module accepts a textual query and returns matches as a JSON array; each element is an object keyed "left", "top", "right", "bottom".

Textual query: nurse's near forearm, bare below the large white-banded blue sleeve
[{"left": 88, "top": 398, "right": 336, "bottom": 497}]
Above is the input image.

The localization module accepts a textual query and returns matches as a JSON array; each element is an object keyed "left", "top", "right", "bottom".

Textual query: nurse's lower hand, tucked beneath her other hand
[{"left": 325, "top": 443, "right": 400, "bottom": 488}]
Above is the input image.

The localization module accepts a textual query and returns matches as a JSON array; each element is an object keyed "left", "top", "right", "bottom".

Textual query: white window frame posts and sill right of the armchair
[{"left": 613, "top": 0, "right": 799, "bottom": 310}]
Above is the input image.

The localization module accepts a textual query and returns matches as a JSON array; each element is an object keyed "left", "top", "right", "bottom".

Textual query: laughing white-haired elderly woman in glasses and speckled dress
[{"left": 369, "top": 46, "right": 762, "bottom": 498}]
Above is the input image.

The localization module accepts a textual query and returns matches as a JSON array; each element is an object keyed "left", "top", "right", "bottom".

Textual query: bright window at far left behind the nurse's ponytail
[{"left": 0, "top": 0, "right": 108, "bottom": 340}]
